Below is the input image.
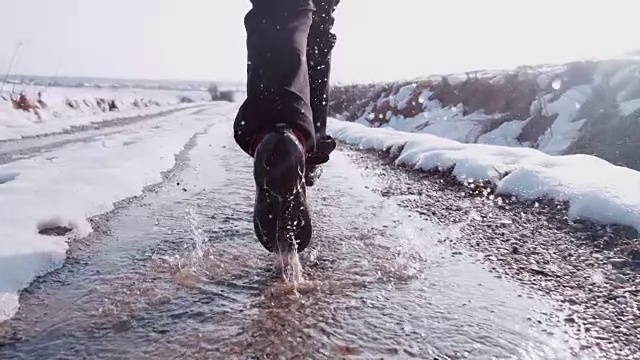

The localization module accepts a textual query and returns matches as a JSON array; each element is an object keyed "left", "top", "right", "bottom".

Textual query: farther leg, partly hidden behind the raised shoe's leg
[{"left": 305, "top": 0, "right": 340, "bottom": 186}]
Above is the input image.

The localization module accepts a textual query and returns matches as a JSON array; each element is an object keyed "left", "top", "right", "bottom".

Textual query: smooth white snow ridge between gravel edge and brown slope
[{"left": 328, "top": 119, "right": 640, "bottom": 231}]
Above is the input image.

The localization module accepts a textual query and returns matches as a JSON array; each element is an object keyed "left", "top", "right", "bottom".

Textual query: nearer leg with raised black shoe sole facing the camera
[{"left": 234, "top": 0, "right": 315, "bottom": 253}]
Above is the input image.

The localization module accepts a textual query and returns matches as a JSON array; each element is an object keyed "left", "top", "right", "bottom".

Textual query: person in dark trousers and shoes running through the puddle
[{"left": 233, "top": 0, "right": 340, "bottom": 253}]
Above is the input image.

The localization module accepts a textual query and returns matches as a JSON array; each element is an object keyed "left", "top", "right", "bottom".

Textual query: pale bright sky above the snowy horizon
[{"left": 0, "top": 0, "right": 640, "bottom": 82}]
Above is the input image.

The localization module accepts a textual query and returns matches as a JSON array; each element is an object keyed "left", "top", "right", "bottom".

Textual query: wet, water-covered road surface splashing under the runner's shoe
[{"left": 0, "top": 107, "right": 587, "bottom": 359}]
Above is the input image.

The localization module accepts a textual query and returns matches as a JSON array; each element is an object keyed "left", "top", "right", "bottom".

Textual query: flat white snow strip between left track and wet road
[{"left": 0, "top": 105, "right": 233, "bottom": 321}]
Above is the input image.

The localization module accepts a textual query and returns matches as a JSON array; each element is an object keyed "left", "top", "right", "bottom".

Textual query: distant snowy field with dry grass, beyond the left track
[{"left": 0, "top": 87, "right": 211, "bottom": 140}]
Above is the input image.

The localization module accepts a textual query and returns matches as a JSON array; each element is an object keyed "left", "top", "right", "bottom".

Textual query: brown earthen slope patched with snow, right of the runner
[{"left": 330, "top": 57, "right": 640, "bottom": 163}]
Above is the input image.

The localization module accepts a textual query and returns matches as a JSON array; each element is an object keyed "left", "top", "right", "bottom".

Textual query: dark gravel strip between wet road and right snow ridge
[{"left": 342, "top": 144, "right": 640, "bottom": 359}]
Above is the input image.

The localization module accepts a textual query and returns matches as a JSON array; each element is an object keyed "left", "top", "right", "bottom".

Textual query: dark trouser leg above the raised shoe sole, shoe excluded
[{"left": 234, "top": 0, "right": 315, "bottom": 156}]
